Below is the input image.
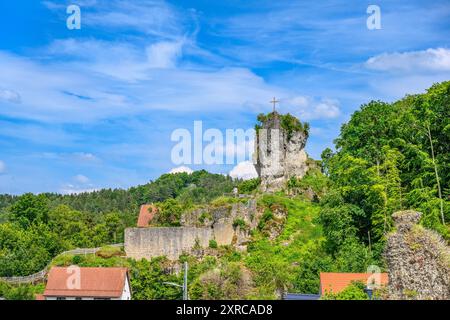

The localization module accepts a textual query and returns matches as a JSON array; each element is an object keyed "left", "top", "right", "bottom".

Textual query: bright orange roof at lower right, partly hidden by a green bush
[{"left": 320, "top": 272, "right": 388, "bottom": 294}]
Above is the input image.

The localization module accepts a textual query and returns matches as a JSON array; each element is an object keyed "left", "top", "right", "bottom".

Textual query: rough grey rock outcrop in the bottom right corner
[{"left": 385, "top": 211, "right": 450, "bottom": 300}]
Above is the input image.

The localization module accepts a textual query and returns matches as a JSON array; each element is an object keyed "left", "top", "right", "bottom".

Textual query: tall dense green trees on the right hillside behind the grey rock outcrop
[{"left": 320, "top": 82, "right": 450, "bottom": 270}]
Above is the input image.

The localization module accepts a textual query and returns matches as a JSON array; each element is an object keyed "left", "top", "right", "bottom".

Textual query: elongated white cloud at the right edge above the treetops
[{"left": 365, "top": 48, "right": 450, "bottom": 72}]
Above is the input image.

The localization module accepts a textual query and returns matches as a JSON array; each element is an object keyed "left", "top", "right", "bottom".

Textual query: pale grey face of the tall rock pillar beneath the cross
[{"left": 253, "top": 111, "right": 308, "bottom": 192}]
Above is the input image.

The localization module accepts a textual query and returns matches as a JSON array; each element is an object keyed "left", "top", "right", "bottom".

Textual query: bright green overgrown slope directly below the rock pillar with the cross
[{"left": 244, "top": 194, "right": 329, "bottom": 299}]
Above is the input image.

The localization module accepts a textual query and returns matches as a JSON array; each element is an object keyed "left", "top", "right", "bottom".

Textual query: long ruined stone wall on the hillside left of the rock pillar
[{"left": 125, "top": 199, "right": 259, "bottom": 260}]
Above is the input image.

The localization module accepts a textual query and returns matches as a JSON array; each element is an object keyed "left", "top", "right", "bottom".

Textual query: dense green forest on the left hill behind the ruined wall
[{"left": 0, "top": 170, "right": 240, "bottom": 277}]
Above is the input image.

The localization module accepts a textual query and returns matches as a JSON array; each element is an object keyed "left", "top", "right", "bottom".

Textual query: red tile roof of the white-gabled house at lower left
[{"left": 44, "top": 267, "right": 128, "bottom": 298}]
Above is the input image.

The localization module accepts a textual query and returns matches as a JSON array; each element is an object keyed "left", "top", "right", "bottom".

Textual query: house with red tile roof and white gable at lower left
[{"left": 43, "top": 266, "right": 131, "bottom": 300}]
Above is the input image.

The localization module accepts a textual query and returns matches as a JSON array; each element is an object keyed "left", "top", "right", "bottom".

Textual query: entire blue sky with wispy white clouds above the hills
[{"left": 0, "top": 0, "right": 450, "bottom": 194}]
